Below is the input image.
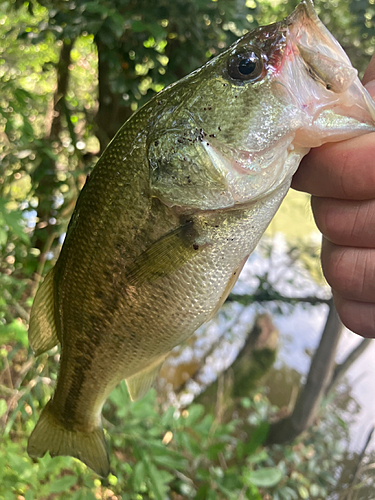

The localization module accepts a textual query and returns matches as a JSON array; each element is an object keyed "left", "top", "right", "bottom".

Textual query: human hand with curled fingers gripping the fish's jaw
[{"left": 292, "top": 56, "right": 375, "bottom": 337}]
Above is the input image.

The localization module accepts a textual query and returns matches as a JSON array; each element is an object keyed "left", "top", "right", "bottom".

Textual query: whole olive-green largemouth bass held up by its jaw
[{"left": 28, "top": 0, "right": 375, "bottom": 476}]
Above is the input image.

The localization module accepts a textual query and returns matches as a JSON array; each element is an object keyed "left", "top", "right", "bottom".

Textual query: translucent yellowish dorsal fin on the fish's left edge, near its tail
[{"left": 29, "top": 268, "right": 59, "bottom": 356}]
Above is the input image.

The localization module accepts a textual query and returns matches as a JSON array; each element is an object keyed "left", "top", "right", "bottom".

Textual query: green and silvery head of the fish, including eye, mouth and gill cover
[{"left": 149, "top": 0, "right": 375, "bottom": 210}]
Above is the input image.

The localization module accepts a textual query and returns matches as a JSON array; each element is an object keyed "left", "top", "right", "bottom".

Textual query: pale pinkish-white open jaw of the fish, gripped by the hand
[{"left": 273, "top": 0, "right": 375, "bottom": 147}]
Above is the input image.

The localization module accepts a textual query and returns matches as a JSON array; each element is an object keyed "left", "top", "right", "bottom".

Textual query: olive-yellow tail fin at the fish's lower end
[{"left": 27, "top": 401, "right": 109, "bottom": 477}]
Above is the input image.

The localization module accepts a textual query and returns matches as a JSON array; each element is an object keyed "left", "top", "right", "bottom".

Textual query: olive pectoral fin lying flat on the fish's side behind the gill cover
[{"left": 127, "top": 222, "right": 207, "bottom": 286}]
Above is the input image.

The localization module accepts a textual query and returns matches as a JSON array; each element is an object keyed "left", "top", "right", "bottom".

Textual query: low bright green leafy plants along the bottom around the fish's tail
[{"left": 0, "top": 376, "right": 364, "bottom": 500}]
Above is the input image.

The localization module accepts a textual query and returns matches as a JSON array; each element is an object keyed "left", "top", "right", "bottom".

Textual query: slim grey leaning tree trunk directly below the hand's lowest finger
[{"left": 267, "top": 300, "right": 342, "bottom": 444}]
